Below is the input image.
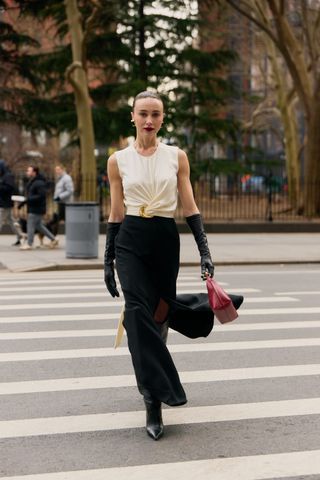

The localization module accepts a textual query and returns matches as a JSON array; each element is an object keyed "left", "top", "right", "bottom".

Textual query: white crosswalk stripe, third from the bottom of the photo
[{"left": 0, "top": 364, "right": 320, "bottom": 395}]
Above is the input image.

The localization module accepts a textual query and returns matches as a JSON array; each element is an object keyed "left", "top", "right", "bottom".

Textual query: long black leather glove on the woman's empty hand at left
[{"left": 104, "top": 222, "right": 121, "bottom": 297}]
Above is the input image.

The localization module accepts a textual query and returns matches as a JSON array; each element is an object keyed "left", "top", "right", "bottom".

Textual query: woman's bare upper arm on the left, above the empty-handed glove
[{"left": 108, "top": 155, "right": 124, "bottom": 223}]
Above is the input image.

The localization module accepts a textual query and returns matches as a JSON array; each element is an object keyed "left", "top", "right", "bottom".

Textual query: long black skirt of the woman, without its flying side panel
[{"left": 115, "top": 215, "right": 187, "bottom": 406}]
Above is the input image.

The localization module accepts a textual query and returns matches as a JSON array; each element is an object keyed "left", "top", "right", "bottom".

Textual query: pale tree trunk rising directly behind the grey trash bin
[{"left": 64, "top": 0, "right": 97, "bottom": 201}]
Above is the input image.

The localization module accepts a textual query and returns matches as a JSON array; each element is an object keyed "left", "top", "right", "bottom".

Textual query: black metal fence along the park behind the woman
[{"left": 11, "top": 176, "right": 320, "bottom": 222}]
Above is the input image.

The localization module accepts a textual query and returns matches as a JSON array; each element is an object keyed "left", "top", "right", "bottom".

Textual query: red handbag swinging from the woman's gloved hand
[{"left": 206, "top": 277, "right": 238, "bottom": 323}]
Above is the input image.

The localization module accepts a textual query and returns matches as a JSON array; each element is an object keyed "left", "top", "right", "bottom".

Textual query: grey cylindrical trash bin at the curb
[{"left": 65, "top": 202, "right": 99, "bottom": 258}]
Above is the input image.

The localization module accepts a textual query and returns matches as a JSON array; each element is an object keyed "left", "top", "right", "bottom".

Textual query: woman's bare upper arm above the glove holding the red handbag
[{"left": 177, "top": 150, "right": 199, "bottom": 217}]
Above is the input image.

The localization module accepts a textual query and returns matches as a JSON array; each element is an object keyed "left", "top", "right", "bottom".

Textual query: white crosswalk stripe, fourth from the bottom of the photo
[{"left": 0, "top": 338, "right": 320, "bottom": 362}]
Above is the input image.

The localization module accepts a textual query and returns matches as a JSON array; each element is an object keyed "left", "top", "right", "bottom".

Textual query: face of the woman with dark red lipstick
[{"left": 131, "top": 97, "right": 163, "bottom": 136}]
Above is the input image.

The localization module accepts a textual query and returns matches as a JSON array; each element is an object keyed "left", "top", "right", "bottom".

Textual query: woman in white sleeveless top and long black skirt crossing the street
[{"left": 104, "top": 91, "right": 214, "bottom": 440}]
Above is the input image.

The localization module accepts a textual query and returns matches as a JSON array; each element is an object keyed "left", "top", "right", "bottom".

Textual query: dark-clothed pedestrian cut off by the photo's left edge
[{"left": 0, "top": 159, "right": 22, "bottom": 246}]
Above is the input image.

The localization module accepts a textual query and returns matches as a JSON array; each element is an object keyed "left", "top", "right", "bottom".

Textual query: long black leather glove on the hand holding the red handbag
[{"left": 186, "top": 213, "right": 214, "bottom": 280}]
